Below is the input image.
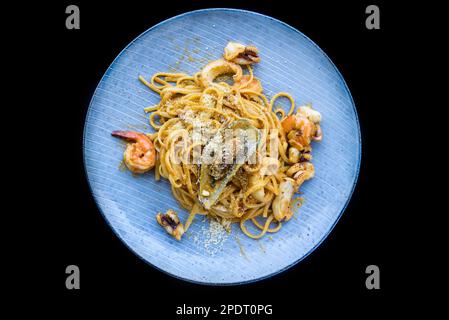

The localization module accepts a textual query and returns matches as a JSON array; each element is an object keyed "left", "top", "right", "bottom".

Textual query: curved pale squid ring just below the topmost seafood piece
[{"left": 201, "top": 59, "right": 243, "bottom": 87}]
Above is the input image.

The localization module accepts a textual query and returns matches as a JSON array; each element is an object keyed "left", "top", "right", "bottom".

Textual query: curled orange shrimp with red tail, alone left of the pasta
[{"left": 112, "top": 131, "right": 156, "bottom": 173}]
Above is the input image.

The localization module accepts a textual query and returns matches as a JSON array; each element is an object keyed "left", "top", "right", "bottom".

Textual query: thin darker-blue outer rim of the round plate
[{"left": 82, "top": 8, "right": 362, "bottom": 286}]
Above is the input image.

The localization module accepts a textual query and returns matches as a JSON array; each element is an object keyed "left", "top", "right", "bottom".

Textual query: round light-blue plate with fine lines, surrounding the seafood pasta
[{"left": 84, "top": 9, "right": 361, "bottom": 284}]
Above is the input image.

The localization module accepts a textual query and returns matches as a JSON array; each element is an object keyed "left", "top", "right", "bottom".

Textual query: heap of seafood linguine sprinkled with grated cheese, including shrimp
[{"left": 112, "top": 42, "right": 323, "bottom": 240}]
